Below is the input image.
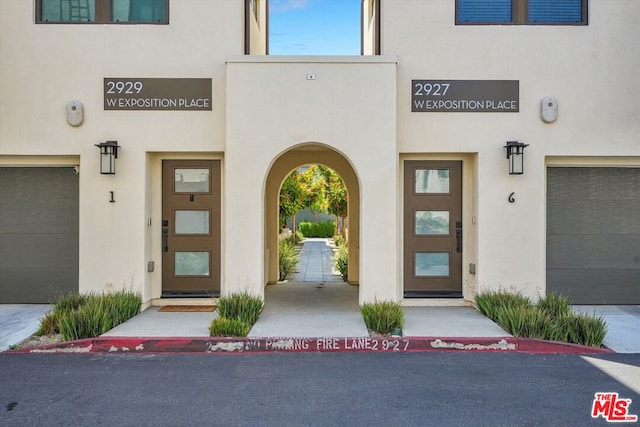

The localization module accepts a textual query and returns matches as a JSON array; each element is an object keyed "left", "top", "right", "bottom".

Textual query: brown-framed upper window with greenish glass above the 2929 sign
[{"left": 36, "top": 0, "right": 169, "bottom": 24}]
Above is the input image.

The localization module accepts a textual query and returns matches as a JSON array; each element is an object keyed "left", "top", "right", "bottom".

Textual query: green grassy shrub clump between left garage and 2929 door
[{"left": 49, "top": 290, "right": 142, "bottom": 341}]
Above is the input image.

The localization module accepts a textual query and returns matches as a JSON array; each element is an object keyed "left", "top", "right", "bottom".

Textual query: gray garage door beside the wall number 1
[{"left": 0, "top": 167, "right": 78, "bottom": 304}]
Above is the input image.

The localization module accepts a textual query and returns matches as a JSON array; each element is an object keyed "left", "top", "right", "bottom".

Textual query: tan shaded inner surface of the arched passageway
[{"left": 264, "top": 144, "right": 360, "bottom": 290}]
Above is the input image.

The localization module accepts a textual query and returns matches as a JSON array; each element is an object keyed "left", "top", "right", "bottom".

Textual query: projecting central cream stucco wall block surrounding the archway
[{"left": 222, "top": 57, "right": 397, "bottom": 300}]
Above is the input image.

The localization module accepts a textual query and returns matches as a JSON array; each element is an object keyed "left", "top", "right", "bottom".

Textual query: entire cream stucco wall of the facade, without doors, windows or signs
[{"left": 0, "top": 0, "right": 640, "bottom": 301}]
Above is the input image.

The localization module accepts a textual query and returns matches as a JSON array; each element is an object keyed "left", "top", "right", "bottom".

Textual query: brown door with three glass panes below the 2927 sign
[{"left": 404, "top": 161, "right": 462, "bottom": 298}]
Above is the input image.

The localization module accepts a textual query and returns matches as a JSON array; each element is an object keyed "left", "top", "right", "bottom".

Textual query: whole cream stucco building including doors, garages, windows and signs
[{"left": 0, "top": 0, "right": 640, "bottom": 305}]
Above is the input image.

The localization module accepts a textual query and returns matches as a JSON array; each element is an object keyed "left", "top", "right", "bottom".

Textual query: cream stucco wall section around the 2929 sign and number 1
[{"left": 0, "top": 0, "right": 244, "bottom": 299}]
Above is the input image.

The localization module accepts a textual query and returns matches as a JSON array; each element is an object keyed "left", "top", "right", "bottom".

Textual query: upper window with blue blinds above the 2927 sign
[{"left": 456, "top": 0, "right": 587, "bottom": 25}]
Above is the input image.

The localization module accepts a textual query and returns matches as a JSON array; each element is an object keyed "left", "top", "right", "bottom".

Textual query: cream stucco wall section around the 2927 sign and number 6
[{"left": 381, "top": 0, "right": 640, "bottom": 296}]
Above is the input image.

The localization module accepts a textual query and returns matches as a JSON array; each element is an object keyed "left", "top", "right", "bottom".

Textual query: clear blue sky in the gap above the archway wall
[{"left": 269, "top": 0, "right": 361, "bottom": 55}]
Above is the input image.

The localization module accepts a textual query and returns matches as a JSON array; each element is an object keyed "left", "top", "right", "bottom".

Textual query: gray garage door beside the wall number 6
[{"left": 547, "top": 167, "right": 640, "bottom": 304}]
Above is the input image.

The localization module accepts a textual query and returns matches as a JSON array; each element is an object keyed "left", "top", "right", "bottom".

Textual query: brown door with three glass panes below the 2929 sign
[{"left": 162, "top": 160, "right": 221, "bottom": 297}]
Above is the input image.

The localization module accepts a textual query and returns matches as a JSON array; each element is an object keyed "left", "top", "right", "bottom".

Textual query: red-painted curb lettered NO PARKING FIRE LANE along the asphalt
[{"left": 5, "top": 337, "right": 613, "bottom": 354}]
